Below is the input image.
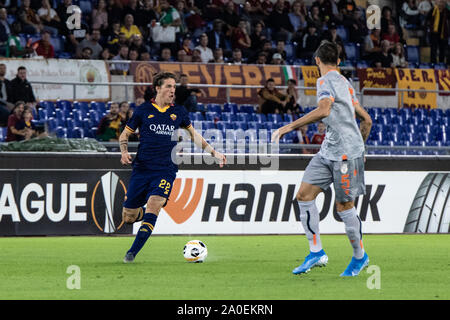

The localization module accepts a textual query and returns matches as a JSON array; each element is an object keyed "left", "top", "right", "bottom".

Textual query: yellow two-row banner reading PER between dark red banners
[{"left": 395, "top": 69, "right": 437, "bottom": 109}]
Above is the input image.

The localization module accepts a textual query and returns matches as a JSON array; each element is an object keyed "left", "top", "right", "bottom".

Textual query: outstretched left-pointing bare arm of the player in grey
[{"left": 272, "top": 98, "right": 333, "bottom": 142}]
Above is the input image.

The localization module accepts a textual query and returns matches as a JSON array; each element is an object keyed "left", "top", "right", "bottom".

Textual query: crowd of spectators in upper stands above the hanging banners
[{"left": 0, "top": 0, "right": 450, "bottom": 68}]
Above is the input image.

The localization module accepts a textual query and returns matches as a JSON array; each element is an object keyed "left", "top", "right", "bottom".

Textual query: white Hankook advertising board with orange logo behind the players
[{"left": 147, "top": 171, "right": 428, "bottom": 234}]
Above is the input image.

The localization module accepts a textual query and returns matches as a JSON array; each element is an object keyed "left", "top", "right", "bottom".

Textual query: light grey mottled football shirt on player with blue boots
[{"left": 317, "top": 70, "right": 364, "bottom": 161}]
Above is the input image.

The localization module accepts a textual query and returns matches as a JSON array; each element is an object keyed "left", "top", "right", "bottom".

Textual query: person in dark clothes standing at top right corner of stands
[{"left": 428, "top": 0, "right": 450, "bottom": 64}]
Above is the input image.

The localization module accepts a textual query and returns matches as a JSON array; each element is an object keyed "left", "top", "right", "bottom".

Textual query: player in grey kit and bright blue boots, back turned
[{"left": 272, "top": 41, "right": 372, "bottom": 276}]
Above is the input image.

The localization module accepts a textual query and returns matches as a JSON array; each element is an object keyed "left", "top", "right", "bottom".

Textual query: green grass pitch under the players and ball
[{"left": 0, "top": 234, "right": 450, "bottom": 300}]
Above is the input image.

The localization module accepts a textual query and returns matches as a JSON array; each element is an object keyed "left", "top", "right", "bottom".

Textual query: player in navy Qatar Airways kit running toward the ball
[{"left": 119, "top": 72, "right": 226, "bottom": 263}]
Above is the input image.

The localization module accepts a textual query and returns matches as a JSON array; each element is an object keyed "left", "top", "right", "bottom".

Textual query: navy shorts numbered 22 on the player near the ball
[{"left": 123, "top": 169, "right": 176, "bottom": 209}]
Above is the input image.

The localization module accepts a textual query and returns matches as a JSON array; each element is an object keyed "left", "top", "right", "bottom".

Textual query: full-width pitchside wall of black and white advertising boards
[{"left": 0, "top": 153, "right": 450, "bottom": 236}]
